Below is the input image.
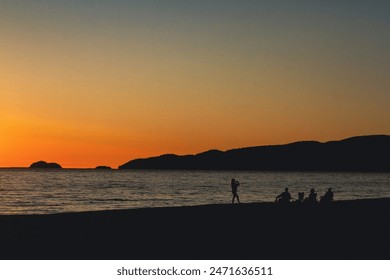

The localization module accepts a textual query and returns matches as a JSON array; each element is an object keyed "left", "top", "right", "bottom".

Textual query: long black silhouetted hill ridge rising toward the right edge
[{"left": 119, "top": 135, "right": 390, "bottom": 172}]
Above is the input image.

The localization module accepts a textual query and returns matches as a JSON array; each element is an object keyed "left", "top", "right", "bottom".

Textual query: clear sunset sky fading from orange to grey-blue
[{"left": 0, "top": 0, "right": 390, "bottom": 168}]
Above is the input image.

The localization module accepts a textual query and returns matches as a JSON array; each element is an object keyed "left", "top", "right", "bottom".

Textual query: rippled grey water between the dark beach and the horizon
[{"left": 0, "top": 169, "right": 390, "bottom": 214}]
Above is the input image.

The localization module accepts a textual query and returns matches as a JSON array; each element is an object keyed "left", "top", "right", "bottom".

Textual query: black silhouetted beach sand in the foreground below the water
[{"left": 0, "top": 199, "right": 390, "bottom": 260}]
